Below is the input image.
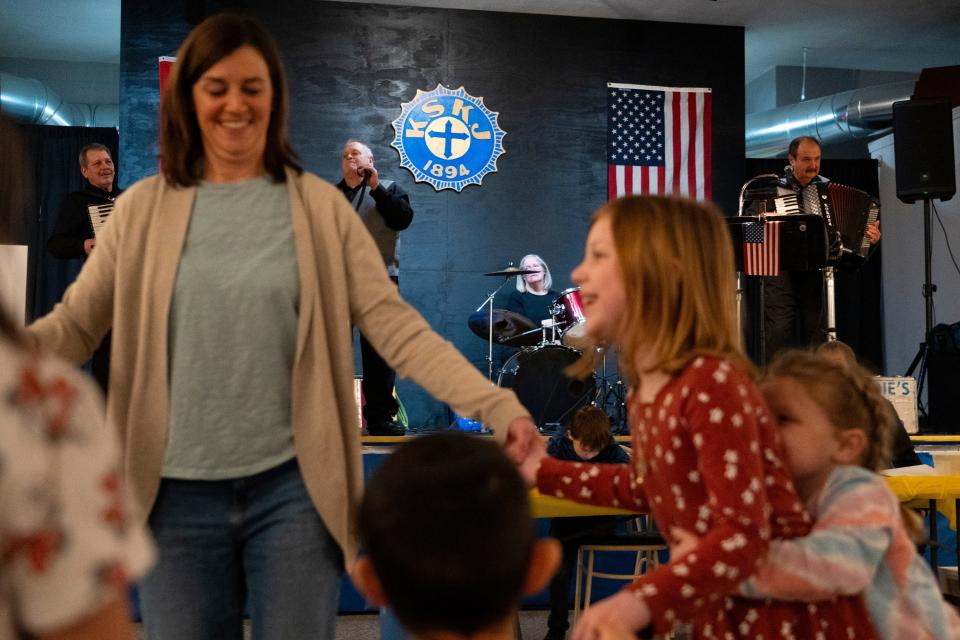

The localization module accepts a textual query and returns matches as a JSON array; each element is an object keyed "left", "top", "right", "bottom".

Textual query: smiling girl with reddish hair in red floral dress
[{"left": 508, "top": 197, "right": 876, "bottom": 640}]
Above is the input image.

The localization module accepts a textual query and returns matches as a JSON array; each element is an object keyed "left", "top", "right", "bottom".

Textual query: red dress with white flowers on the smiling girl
[{"left": 537, "top": 356, "right": 876, "bottom": 640}]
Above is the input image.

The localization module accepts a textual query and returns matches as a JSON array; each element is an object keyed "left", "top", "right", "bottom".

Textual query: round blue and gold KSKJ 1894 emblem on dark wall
[{"left": 391, "top": 84, "right": 506, "bottom": 191}]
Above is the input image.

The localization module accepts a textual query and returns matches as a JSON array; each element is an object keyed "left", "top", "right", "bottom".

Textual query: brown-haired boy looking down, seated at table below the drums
[{"left": 544, "top": 405, "right": 630, "bottom": 640}]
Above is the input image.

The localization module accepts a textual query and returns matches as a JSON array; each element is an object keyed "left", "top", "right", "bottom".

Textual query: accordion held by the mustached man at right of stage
[{"left": 748, "top": 182, "right": 880, "bottom": 267}]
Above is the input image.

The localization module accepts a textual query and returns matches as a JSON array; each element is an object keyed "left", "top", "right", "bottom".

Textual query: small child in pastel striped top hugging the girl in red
[{"left": 671, "top": 351, "right": 960, "bottom": 640}]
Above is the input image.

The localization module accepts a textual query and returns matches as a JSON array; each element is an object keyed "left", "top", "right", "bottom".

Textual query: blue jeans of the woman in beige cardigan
[{"left": 140, "top": 460, "right": 343, "bottom": 640}]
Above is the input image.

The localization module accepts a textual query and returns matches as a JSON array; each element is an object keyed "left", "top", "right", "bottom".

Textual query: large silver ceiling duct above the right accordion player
[{"left": 746, "top": 80, "right": 916, "bottom": 158}]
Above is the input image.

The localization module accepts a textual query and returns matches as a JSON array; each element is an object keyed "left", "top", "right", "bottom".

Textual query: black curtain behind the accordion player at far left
[{"left": 17, "top": 125, "right": 120, "bottom": 322}]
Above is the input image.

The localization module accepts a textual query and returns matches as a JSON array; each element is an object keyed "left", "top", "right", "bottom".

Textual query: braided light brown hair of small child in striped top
[{"left": 766, "top": 350, "right": 896, "bottom": 471}]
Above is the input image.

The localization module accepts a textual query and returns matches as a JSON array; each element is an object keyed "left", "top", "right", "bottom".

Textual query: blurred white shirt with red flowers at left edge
[{"left": 0, "top": 339, "right": 152, "bottom": 640}]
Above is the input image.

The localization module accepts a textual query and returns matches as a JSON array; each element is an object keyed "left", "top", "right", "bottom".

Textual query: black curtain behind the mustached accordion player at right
[{"left": 745, "top": 154, "right": 883, "bottom": 373}]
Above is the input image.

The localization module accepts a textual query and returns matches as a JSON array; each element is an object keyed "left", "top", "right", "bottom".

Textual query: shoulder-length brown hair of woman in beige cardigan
[{"left": 160, "top": 13, "right": 302, "bottom": 187}]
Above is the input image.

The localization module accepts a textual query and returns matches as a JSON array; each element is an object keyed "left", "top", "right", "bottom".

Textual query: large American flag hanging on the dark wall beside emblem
[{"left": 607, "top": 82, "right": 712, "bottom": 200}]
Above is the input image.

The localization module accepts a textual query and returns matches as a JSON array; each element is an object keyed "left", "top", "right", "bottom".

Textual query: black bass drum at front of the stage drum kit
[{"left": 497, "top": 344, "right": 596, "bottom": 430}]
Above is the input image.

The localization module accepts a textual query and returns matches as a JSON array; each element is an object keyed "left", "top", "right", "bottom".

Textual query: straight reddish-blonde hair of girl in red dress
[{"left": 593, "top": 196, "right": 754, "bottom": 380}]
